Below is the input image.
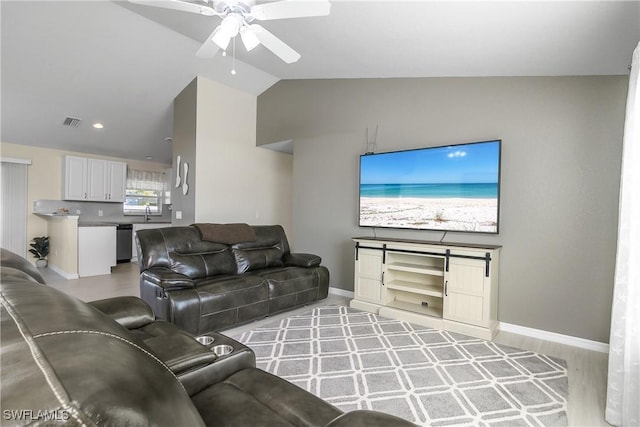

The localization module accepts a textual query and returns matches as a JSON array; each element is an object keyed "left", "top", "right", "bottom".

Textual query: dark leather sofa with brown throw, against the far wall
[{"left": 136, "top": 224, "right": 329, "bottom": 334}]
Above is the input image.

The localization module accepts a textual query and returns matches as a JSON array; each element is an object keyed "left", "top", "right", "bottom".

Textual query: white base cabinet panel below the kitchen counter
[{"left": 78, "top": 225, "right": 116, "bottom": 277}]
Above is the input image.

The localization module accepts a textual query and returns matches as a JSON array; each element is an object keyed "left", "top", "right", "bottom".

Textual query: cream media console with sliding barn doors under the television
[{"left": 350, "top": 237, "right": 500, "bottom": 340}]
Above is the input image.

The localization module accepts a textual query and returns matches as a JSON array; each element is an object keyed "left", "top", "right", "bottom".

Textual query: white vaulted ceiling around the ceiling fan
[{"left": 0, "top": 0, "right": 640, "bottom": 163}]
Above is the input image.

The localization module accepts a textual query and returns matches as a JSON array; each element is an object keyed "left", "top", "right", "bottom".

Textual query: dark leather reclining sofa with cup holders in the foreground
[{"left": 0, "top": 251, "right": 413, "bottom": 427}]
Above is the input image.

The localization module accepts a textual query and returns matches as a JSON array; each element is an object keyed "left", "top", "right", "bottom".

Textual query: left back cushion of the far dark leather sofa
[{"left": 136, "top": 227, "right": 236, "bottom": 279}]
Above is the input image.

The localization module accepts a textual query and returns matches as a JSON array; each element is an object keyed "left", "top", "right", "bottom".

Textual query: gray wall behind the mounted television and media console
[{"left": 257, "top": 76, "right": 628, "bottom": 342}]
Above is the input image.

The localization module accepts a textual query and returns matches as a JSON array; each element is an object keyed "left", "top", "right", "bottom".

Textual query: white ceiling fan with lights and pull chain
[{"left": 129, "top": 0, "right": 331, "bottom": 64}]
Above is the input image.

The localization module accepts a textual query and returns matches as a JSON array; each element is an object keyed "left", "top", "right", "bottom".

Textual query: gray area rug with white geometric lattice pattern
[{"left": 237, "top": 306, "right": 568, "bottom": 427}]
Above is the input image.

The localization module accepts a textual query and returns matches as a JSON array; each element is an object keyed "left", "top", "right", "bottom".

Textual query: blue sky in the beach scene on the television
[{"left": 360, "top": 141, "right": 500, "bottom": 184}]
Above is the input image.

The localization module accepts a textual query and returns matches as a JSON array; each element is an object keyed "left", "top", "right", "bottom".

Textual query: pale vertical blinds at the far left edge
[{"left": 0, "top": 159, "right": 30, "bottom": 257}]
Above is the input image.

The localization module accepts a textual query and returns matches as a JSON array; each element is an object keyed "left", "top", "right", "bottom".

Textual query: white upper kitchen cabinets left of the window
[{"left": 63, "top": 156, "right": 127, "bottom": 203}]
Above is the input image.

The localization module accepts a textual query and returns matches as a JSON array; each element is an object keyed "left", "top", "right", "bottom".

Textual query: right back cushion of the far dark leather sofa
[{"left": 232, "top": 225, "right": 289, "bottom": 274}]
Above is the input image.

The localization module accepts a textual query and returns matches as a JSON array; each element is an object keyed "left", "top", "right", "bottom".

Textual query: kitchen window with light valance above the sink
[{"left": 123, "top": 169, "right": 165, "bottom": 215}]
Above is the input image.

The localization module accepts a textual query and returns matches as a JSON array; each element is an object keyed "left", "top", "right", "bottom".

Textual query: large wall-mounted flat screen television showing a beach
[{"left": 359, "top": 140, "right": 501, "bottom": 234}]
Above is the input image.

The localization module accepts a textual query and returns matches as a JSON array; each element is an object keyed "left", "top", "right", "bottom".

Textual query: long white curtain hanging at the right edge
[{"left": 605, "top": 44, "right": 640, "bottom": 427}]
